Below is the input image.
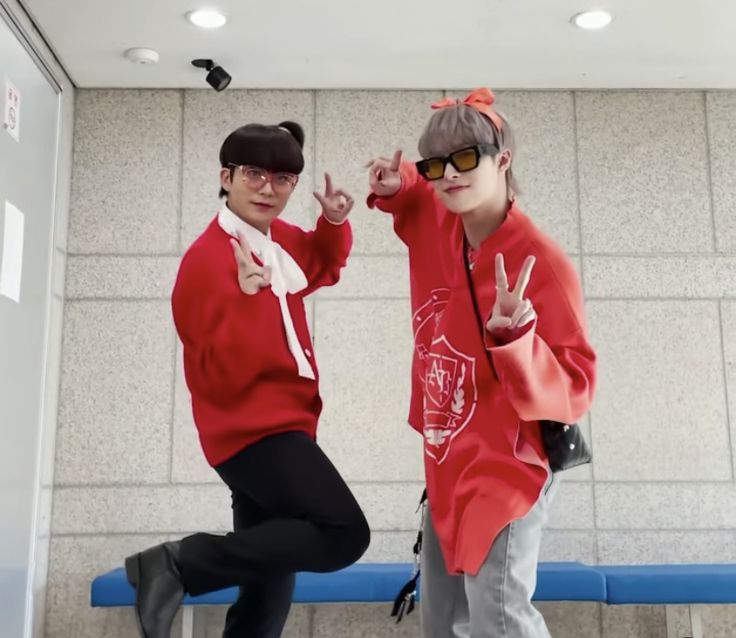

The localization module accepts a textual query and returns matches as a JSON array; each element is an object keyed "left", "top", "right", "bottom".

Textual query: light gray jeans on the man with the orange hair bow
[{"left": 420, "top": 475, "right": 559, "bottom": 638}]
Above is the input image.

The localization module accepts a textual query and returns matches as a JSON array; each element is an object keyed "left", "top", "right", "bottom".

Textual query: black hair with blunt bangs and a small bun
[{"left": 220, "top": 121, "right": 304, "bottom": 197}]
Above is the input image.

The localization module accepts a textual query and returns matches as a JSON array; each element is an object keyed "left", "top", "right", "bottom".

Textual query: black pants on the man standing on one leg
[{"left": 180, "top": 432, "right": 370, "bottom": 638}]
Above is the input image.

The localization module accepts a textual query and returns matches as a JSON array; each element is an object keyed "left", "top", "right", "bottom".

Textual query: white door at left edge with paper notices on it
[{"left": 0, "top": 11, "right": 60, "bottom": 638}]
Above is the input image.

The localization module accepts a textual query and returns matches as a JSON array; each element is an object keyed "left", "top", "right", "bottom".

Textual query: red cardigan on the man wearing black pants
[{"left": 172, "top": 212, "right": 352, "bottom": 467}]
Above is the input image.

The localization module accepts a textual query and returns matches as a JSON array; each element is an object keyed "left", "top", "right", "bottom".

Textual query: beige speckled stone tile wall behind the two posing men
[{"left": 47, "top": 91, "right": 736, "bottom": 638}]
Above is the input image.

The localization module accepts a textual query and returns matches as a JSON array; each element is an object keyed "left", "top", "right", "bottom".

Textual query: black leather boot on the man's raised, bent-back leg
[{"left": 125, "top": 542, "right": 184, "bottom": 638}]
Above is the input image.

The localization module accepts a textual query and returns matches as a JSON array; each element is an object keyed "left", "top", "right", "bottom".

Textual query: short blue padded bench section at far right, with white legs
[{"left": 596, "top": 564, "right": 736, "bottom": 638}]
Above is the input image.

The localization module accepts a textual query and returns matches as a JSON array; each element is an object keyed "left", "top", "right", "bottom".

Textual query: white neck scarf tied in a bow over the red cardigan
[{"left": 217, "top": 205, "right": 315, "bottom": 379}]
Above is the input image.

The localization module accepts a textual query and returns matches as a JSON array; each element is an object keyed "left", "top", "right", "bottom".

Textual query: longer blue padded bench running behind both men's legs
[{"left": 91, "top": 562, "right": 606, "bottom": 638}]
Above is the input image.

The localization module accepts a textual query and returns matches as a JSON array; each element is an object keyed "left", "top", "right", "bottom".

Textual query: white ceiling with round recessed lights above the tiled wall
[{"left": 18, "top": 0, "right": 736, "bottom": 89}]
